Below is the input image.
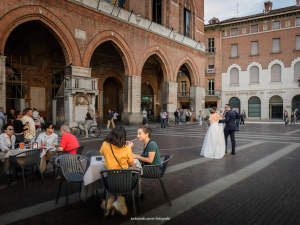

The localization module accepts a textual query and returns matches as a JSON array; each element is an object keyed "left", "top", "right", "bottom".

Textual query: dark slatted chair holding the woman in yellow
[{"left": 100, "top": 169, "right": 141, "bottom": 223}]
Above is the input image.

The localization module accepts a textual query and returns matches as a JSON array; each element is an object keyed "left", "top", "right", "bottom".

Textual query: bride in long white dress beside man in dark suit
[{"left": 200, "top": 107, "right": 225, "bottom": 159}]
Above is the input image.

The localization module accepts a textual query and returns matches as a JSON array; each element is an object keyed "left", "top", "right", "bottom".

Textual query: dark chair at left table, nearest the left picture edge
[{"left": 9, "top": 149, "right": 45, "bottom": 189}]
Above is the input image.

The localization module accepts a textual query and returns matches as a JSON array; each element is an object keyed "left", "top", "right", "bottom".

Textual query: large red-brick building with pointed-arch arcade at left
[{"left": 0, "top": 0, "right": 205, "bottom": 125}]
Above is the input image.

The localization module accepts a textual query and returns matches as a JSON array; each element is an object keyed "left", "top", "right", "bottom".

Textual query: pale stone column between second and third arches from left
[{"left": 122, "top": 75, "right": 143, "bottom": 125}]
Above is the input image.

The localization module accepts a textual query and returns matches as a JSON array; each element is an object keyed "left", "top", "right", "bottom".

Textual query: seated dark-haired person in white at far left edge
[{"left": 0, "top": 124, "right": 16, "bottom": 160}]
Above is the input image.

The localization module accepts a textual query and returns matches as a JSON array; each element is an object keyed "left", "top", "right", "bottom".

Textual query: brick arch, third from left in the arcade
[{"left": 137, "top": 46, "right": 172, "bottom": 82}]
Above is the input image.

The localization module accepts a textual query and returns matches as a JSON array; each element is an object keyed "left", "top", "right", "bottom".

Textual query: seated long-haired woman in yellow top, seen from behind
[{"left": 100, "top": 126, "right": 134, "bottom": 215}]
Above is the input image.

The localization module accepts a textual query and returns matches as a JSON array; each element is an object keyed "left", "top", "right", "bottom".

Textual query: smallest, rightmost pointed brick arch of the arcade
[{"left": 173, "top": 56, "right": 200, "bottom": 86}]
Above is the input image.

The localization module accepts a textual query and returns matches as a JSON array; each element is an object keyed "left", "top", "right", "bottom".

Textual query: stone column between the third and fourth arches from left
[{"left": 162, "top": 82, "right": 178, "bottom": 119}]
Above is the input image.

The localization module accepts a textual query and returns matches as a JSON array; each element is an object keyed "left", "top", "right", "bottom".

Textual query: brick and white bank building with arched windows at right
[{"left": 205, "top": 0, "right": 300, "bottom": 120}]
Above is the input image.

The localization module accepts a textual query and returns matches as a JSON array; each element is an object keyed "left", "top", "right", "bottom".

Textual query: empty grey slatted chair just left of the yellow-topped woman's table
[{"left": 55, "top": 154, "right": 89, "bottom": 206}]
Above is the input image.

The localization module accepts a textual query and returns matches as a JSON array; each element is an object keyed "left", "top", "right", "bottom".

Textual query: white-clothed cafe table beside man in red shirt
[{"left": 2, "top": 146, "right": 56, "bottom": 174}]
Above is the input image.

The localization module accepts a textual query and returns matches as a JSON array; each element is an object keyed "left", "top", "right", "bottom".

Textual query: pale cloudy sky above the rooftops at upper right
[{"left": 204, "top": 0, "right": 296, "bottom": 24}]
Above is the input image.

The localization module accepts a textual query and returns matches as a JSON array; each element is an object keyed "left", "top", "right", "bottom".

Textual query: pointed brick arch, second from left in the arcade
[{"left": 82, "top": 31, "right": 136, "bottom": 75}]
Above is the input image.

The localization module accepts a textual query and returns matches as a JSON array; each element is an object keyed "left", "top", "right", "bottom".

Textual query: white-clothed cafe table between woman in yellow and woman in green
[{"left": 81, "top": 156, "right": 143, "bottom": 201}]
